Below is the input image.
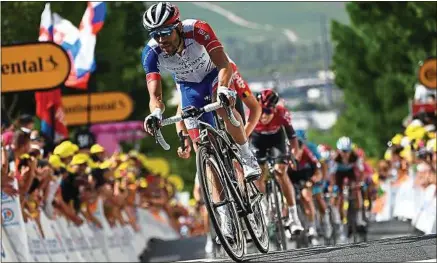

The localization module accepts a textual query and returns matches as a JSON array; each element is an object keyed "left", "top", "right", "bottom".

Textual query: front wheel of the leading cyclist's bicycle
[{"left": 196, "top": 146, "right": 246, "bottom": 261}]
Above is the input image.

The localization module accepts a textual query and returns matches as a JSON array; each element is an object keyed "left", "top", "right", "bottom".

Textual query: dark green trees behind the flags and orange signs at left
[{"left": 1, "top": 2, "right": 195, "bottom": 192}]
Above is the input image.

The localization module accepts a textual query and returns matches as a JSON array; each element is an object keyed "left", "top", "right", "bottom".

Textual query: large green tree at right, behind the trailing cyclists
[{"left": 331, "top": 2, "right": 437, "bottom": 156}]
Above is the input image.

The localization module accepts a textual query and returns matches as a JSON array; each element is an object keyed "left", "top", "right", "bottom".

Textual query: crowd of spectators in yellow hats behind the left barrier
[{"left": 1, "top": 114, "right": 209, "bottom": 248}]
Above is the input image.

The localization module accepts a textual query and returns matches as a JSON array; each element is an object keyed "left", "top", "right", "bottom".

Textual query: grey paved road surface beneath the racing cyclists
[{"left": 143, "top": 221, "right": 437, "bottom": 262}]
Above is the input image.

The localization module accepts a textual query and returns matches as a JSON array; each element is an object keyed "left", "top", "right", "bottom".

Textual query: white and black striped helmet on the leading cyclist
[{"left": 143, "top": 2, "right": 180, "bottom": 30}]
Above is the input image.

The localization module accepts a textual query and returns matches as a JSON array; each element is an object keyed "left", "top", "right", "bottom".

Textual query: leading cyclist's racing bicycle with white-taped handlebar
[{"left": 151, "top": 94, "right": 269, "bottom": 261}]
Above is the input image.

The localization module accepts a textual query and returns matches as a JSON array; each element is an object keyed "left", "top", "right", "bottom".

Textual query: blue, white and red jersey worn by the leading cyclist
[{"left": 141, "top": 19, "right": 227, "bottom": 135}]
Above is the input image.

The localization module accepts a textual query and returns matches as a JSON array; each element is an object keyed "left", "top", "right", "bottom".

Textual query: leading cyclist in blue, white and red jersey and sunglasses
[{"left": 141, "top": 2, "right": 261, "bottom": 180}]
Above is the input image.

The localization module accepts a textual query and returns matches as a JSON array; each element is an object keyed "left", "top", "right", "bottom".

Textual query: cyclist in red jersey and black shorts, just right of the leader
[{"left": 250, "top": 89, "right": 303, "bottom": 234}]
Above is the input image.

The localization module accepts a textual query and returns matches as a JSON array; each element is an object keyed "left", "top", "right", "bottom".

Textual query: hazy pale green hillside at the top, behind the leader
[{"left": 176, "top": 2, "right": 348, "bottom": 43}]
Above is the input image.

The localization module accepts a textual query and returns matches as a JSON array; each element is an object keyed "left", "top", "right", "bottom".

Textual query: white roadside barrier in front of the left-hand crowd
[{"left": 1, "top": 196, "right": 179, "bottom": 262}]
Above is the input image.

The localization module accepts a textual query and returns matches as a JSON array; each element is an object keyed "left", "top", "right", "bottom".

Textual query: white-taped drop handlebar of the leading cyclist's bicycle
[{"left": 152, "top": 94, "right": 240, "bottom": 151}]
